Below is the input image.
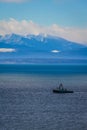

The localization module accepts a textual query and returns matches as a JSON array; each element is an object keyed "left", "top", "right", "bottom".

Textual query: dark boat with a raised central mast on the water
[{"left": 53, "top": 83, "right": 74, "bottom": 93}]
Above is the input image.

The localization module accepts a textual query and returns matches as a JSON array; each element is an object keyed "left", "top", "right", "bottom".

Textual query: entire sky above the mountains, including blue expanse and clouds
[{"left": 0, "top": 0, "right": 87, "bottom": 44}]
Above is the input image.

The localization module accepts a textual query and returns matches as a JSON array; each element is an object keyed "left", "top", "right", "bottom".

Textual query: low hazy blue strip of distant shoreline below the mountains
[{"left": 0, "top": 58, "right": 87, "bottom": 65}]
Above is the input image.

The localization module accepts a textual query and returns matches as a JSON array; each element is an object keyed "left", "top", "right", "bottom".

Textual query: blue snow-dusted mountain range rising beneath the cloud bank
[{"left": 0, "top": 34, "right": 87, "bottom": 63}]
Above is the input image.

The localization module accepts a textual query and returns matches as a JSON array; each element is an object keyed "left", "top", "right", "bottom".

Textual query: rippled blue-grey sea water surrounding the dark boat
[{"left": 0, "top": 65, "right": 87, "bottom": 130}]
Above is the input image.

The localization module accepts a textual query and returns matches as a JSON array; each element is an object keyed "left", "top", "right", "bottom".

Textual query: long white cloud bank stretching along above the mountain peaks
[{"left": 0, "top": 18, "right": 87, "bottom": 44}]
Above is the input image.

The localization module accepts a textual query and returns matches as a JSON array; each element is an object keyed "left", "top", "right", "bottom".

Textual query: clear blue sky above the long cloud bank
[{"left": 0, "top": 0, "right": 87, "bottom": 27}]
